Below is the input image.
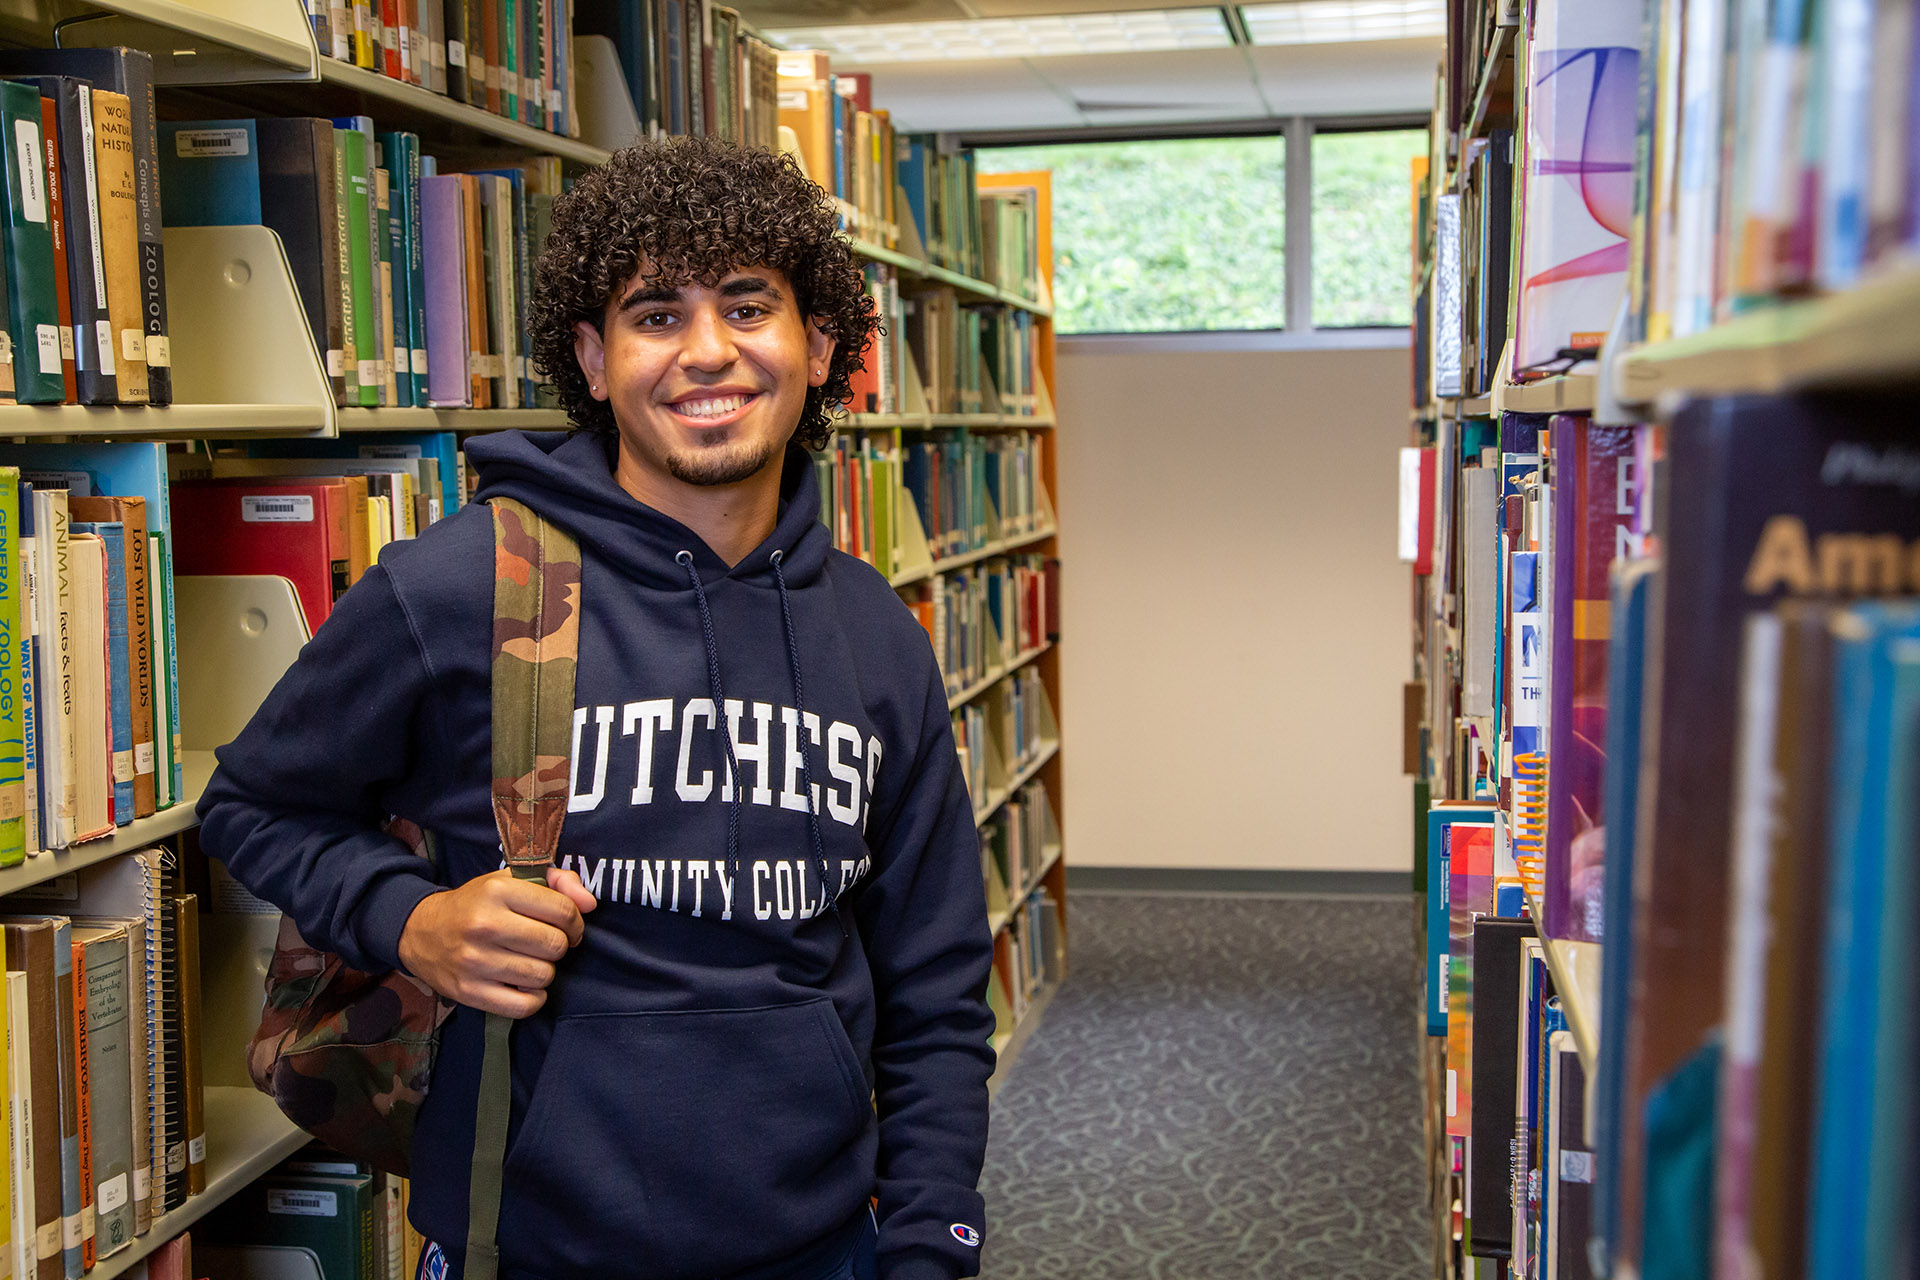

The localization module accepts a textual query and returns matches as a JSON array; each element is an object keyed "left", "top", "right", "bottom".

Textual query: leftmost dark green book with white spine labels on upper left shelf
[{"left": 0, "top": 81, "right": 67, "bottom": 405}]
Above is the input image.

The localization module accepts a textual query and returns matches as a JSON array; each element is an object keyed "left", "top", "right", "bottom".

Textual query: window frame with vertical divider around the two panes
[{"left": 950, "top": 111, "right": 1430, "bottom": 355}]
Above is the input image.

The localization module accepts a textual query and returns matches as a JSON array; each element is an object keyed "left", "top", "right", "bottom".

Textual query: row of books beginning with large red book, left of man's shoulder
[{"left": 169, "top": 432, "right": 467, "bottom": 631}]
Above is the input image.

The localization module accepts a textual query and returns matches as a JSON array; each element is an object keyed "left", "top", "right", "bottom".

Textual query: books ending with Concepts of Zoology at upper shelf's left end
[{"left": 0, "top": 48, "right": 173, "bottom": 405}]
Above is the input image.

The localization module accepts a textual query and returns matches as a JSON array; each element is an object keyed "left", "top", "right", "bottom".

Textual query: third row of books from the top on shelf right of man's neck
[{"left": 900, "top": 432, "right": 1046, "bottom": 560}]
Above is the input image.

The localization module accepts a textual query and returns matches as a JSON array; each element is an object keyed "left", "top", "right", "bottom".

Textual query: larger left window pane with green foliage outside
[{"left": 977, "top": 136, "right": 1282, "bottom": 334}]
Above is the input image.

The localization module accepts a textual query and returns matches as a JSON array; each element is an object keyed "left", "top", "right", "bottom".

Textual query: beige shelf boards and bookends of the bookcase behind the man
[{"left": 0, "top": 0, "right": 1066, "bottom": 1280}]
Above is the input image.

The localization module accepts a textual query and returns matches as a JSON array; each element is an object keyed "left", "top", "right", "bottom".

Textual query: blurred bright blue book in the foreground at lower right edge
[{"left": 1807, "top": 604, "right": 1920, "bottom": 1280}]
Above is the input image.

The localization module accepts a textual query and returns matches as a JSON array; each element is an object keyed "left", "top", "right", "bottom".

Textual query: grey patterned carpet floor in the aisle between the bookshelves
[{"left": 981, "top": 892, "right": 1430, "bottom": 1280}]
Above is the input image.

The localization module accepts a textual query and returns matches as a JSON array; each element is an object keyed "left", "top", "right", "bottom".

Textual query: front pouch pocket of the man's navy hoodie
[{"left": 499, "top": 998, "right": 876, "bottom": 1280}]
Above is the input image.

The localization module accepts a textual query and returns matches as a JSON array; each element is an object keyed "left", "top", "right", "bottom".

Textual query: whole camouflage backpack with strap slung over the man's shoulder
[{"left": 248, "top": 499, "right": 580, "bottom": 1280}]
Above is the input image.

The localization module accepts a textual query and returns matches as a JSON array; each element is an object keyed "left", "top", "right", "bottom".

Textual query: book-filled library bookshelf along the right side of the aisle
[{"left": 1402, "top": 0, "right": 1920, "bottom": 1280}]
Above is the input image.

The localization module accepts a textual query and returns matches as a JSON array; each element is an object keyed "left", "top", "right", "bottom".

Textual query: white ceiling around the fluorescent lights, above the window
[{"left": 741, "top": 0, "right": 1442, "bottom": 132}]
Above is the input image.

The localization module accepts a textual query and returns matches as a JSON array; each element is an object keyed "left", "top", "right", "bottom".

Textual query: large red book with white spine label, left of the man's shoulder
[{"left": 169, "top": 478, "right": 353, "bottom": 631}]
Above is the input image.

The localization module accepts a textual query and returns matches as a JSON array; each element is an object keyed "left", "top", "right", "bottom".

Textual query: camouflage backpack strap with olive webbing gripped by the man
[{"left": 465, "top": 497, "right": 580, "bottom": 1280}]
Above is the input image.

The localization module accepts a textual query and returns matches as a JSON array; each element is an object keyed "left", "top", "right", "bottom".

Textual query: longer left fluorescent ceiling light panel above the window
[{"left": 768, "top": 10, "right": 1233, "bottom": 65}]
